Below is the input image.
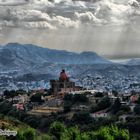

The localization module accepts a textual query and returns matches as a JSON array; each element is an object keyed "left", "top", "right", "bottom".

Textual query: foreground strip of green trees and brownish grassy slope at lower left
[{"left": 0, "top": 116, "right": 130, "bottom": 140}]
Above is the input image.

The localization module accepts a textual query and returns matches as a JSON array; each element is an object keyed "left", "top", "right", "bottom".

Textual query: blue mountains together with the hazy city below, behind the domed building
[{"left": 0, "top": 43, "right": 140, "bottom": 91}]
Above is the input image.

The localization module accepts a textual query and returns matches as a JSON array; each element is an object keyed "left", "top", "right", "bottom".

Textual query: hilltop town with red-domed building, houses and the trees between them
[{"left": 1, "top": 69, "right": 140, "bottom": 121}]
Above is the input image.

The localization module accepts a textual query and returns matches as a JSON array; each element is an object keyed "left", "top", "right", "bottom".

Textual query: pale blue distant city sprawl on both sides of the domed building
[{"left": 0, "top": 67, "right": 140, "bottom": 94}]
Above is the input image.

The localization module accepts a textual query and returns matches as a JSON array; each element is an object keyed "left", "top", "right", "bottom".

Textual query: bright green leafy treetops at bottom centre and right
[{"left": 50, "top": 122, "right": 130, "bottom": 140}]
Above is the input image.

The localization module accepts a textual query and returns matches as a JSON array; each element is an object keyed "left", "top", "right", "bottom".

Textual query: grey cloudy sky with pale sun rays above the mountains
[{"left": 0, "top": 0, "right": 140, "bottom": 59}]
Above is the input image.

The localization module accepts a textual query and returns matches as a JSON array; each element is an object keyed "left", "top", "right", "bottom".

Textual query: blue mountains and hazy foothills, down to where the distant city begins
[{"left": 0, "top": 43, "right": 140, "bottom": 80}]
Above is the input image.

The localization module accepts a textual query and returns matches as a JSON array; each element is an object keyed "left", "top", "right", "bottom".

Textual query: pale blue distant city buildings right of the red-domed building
[{"left": 75, "top": 75, "right": 140, "bottom": 93}]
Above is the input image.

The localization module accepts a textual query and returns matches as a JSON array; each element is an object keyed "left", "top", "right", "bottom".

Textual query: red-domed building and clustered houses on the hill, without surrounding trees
[{"left": 0, "top": 70, "right": 139, "bottom": 118}]
